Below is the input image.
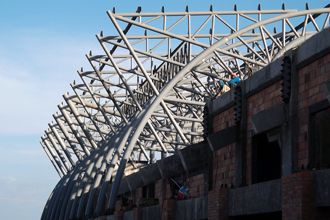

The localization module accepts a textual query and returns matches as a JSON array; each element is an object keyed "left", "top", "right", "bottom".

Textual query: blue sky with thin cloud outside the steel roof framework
[{"left": 0, "top": 0, "right": 328, "bottom": 220}]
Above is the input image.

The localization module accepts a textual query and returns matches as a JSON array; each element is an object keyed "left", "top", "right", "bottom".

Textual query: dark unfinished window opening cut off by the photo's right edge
[{"left": 310, "top": 108, "right": 330, "bottom": 169}]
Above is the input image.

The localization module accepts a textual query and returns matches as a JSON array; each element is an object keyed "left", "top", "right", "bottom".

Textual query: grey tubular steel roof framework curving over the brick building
[{"left": 41, "top": 6, "right": 330, "bottom": 219}]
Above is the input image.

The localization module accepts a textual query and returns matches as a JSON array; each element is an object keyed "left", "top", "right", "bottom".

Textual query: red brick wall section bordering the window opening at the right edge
[{"left": 295, "top": 54, "right": 330, "bottom": 169}]
